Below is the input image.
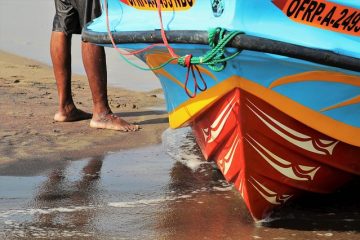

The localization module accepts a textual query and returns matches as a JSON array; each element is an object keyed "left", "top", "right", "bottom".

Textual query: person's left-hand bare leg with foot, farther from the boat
[{"left": 50, "top": 31, "right": 91, "bottom": 122}]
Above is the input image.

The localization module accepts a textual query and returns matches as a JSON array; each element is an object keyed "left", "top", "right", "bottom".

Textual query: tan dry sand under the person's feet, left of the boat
[{"left": 0, "top": 51, "right": 168, "bottom": 164}]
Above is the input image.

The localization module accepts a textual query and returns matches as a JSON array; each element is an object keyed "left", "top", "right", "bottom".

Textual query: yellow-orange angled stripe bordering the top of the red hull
[{"left": 169, "top": 76, "right": 360, "bottom": 147}]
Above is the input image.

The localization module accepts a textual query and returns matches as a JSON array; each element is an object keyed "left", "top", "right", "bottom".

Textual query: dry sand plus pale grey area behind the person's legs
[{"left": 0, "top": 0, "right": 168, "bottom": 169}]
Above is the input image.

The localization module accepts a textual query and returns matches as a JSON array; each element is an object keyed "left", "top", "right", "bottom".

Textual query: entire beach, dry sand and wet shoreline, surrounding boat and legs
[{"left": 0, "top": 0, "right": 360, "bottom": 240}]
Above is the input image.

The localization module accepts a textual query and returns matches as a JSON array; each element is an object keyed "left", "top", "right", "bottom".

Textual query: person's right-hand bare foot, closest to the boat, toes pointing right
[{"left": 90, "top": 113, "right": 140, "bottom": 132}]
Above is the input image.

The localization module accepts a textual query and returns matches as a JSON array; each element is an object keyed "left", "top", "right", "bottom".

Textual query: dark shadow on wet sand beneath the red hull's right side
[{"left": 262, "top": 177, "right": 360, "bottom": 232}]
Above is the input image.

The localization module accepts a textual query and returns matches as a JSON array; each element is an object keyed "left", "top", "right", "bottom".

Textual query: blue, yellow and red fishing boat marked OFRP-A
[{"left": 82, "top": 0, "right": 360, "bottom": 220}]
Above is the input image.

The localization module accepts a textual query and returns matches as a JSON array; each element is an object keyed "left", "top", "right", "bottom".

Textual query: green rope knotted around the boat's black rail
[{"left": 178, "top": 28, "right": 242, "bottom": 72}]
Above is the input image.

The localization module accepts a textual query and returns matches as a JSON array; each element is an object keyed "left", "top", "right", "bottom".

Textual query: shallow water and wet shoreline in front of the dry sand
[{"left": 0, "top": 129, "right": 360, "bottom": 240}]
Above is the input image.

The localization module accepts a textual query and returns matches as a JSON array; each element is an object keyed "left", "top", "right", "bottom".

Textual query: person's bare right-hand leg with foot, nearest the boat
[{"left": 82, "top": 42, "right": 139, "bottom": 131}]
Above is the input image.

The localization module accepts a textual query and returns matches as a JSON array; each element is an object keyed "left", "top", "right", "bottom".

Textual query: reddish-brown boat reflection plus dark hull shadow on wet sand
[{"left": 156, "top": 158, "right": 360, "bottom": 240}]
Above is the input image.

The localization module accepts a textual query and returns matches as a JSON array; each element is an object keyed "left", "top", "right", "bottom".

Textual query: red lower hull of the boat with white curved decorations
[{"left": 192, "top": 88, "right": 360, "bottom": 220}]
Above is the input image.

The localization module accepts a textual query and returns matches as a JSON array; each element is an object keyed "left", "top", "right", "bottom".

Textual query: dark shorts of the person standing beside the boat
[{"left": 52, "top": 0, "right": 101, "bottom": 34}]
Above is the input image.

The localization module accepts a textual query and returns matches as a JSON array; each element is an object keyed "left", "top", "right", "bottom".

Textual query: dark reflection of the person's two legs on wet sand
[{"left": 33, "top": 156, "right": 104, "bottom": 237}]
